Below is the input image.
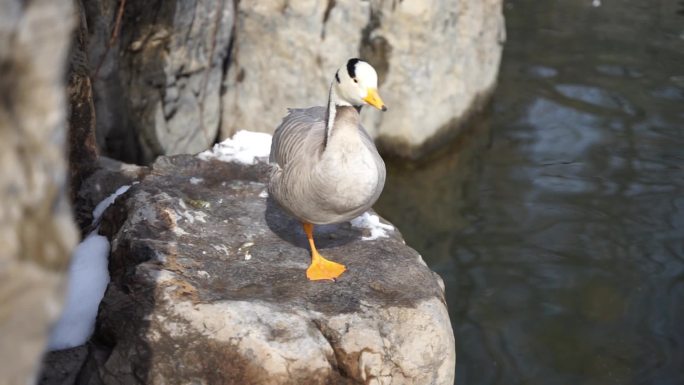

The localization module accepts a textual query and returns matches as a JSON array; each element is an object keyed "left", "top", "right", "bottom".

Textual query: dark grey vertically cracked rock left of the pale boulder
[{"left": 84, "top": 0, "right": 234, "bottom": 163}]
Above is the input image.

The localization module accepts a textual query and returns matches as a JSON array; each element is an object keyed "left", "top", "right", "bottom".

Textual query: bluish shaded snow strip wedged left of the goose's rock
[{"left": 48, "top": 185, "right": 131, "bottom": 350}]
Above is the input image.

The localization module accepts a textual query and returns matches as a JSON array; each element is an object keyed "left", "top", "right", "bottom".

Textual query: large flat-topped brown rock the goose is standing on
[{"left": 86, "top": 155, "right": 455, "bottom": 385}]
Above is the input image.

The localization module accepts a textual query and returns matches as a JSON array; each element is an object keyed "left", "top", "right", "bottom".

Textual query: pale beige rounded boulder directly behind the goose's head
[{"left": 221, "top": 0, "right": 505, "bottom": 156}]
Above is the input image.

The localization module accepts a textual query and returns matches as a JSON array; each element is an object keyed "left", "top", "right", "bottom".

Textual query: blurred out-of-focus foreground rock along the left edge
[{"left": 0, "top": 0, "right": 77, "bottom": 384}]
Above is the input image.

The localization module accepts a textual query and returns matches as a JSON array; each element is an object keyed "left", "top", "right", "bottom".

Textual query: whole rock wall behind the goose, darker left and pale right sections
[{"left": 84, "top": 0, "right": 504, "bottom": 163}]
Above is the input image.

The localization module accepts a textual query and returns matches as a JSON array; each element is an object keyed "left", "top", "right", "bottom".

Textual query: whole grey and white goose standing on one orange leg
[{"left": 268, "top": 59, "right": 387, "bottom": 280}]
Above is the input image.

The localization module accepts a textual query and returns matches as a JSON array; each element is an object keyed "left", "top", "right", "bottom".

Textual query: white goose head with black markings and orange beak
[{"left": 332, "top": 58, "right": 387, "bottom": 111}]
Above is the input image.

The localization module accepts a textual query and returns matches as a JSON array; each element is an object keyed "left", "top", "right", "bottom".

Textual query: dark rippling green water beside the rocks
[{"left": 376, "top": 0, "right": 684, "bottom": 385}]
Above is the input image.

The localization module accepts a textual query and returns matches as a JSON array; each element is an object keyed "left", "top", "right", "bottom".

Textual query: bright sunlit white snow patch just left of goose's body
[{"left": 197, "top": 130, "right": 271, "bottom": 164}]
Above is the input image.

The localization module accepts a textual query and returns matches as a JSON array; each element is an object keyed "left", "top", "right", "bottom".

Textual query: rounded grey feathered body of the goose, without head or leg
[{"left": 268, "top": 106, "right": 385, "bottom": 224}]
